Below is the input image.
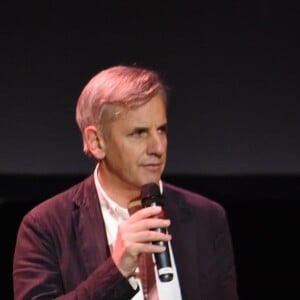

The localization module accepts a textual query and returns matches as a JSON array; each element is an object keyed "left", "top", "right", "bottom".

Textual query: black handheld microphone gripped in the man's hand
[{"left": 141, "top": 183, "right": 173, "bottom": 282}]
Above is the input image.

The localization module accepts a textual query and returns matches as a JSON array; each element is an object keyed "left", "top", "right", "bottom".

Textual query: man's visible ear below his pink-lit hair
[{"left": 84, "top": 125, "right": 105, "bottom": 160}]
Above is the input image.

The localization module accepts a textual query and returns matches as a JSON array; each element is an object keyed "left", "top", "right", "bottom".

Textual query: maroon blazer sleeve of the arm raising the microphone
[{"left": 13, "top": 214, "right": 138, "bottom": 300}]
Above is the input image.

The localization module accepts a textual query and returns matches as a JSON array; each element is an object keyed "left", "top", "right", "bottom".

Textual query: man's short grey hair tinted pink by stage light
[{"left": 76, "top": 65, "right": 167, "bottom": 153}]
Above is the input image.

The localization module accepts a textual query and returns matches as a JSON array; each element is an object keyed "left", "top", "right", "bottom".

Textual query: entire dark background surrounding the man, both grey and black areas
[{"left": 0, "top": 0, "right": 300, "bottom": 300}]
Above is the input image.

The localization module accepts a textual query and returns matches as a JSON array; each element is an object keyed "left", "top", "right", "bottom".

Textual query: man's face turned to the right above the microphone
[{"left": 100, "top": 95, "right": 167, "bottom": 189}]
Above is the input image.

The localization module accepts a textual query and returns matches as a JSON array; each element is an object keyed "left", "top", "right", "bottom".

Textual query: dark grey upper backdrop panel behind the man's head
[{"left": 0, "top": 0, "right": 300, "bottom": 174}]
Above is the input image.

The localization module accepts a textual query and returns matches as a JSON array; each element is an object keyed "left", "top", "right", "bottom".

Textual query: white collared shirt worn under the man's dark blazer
[{"left": 94, "top": 165, "right": 181, "bottom": 300}]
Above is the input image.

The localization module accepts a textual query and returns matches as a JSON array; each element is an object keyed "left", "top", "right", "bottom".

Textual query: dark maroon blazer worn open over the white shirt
[{"left": 13, "top": 175, "right": 238, "bottom": 300}]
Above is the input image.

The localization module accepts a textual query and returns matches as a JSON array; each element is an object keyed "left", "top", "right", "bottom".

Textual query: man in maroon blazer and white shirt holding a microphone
[{"left": 13, "top": 66, "right": 238, "bottom": 300}]
